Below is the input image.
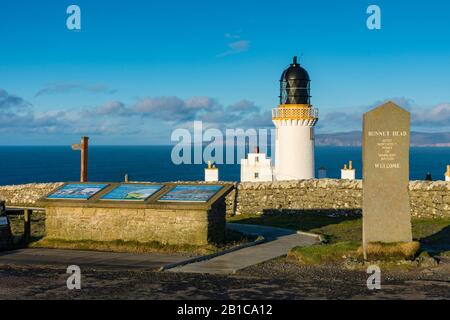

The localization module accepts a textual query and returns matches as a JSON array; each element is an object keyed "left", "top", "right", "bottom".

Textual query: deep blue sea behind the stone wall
[{"left": 0, "top": 146, "right": 450, "bottom": 185}]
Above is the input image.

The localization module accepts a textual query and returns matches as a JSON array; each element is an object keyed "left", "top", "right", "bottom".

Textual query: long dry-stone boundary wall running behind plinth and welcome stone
[{"left": 0, "top": 179, "right": 450, "bottom": 218}]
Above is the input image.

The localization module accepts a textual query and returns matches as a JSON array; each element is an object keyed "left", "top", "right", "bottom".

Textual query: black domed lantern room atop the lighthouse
[{"left": 280, "top": 57, "right": 311, "bottom": 104}]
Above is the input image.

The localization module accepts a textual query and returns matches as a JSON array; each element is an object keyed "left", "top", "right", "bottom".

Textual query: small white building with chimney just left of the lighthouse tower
[{"left": 241, "top": 148, "right": 273, "bottom": 182}]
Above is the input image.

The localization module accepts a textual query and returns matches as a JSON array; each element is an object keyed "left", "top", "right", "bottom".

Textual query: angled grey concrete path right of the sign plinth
[{"left": 167, "top": 223, "right": 320, "bottom": 274}]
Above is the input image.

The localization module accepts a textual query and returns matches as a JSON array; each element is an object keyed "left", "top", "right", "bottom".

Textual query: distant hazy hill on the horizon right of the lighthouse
[{"left": 316, "top": 131, "right": 450, "bottom": 147}]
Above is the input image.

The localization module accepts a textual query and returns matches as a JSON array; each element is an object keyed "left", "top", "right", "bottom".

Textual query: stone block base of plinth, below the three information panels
[{"left": 45, "top": 206, "right": 225, "bottom": 245}]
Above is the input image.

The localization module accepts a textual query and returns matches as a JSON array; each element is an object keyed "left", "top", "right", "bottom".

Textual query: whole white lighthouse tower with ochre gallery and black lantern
[{"left": 272, "top": 57, "right": 319, "bottom": 181}]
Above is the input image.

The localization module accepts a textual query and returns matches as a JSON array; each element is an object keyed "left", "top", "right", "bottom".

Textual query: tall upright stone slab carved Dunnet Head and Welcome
[{"left": 363, "top": 102, "right": 412, "bottom": 245}]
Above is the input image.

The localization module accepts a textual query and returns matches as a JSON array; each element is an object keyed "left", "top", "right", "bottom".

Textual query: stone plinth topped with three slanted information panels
[{"left": 40, "top": 183, "right": 232, "bottom": 245}]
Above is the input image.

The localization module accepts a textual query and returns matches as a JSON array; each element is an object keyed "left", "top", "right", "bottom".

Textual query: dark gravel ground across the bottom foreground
[{"left": 0, "top": 259, "right": 450, "bottom": 300}]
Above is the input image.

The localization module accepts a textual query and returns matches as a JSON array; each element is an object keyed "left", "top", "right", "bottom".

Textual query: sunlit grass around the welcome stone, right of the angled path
[{"left": 228, "top": 213, "right": 450, "bottom": 264}]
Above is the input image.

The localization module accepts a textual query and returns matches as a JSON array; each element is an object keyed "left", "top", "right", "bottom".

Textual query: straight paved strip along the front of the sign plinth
[{"left": 0, "top": 249, "right": 187, "bottom": 270}]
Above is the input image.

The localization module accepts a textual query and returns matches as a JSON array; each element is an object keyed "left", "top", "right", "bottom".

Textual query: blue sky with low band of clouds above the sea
[{"left": 0, "top": 0, "right": 450, "bottom": 145}]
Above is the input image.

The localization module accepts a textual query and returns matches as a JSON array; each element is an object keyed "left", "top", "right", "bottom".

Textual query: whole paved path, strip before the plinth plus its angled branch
[{"left": 0, "top": 223, "right": 318, "bottom": 274}]
